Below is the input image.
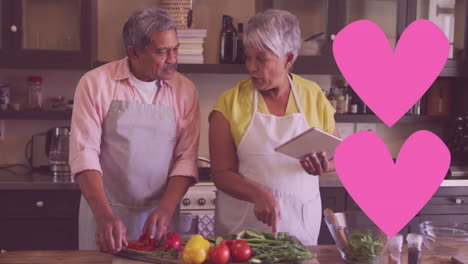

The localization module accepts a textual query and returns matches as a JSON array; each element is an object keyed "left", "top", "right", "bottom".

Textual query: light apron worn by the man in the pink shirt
[{"left": 79, "top": 80, "right": 179, "bottom": 250}]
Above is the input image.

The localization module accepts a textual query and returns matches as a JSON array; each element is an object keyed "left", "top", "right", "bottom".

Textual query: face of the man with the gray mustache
[{"left": 128, "top": 30, "right": 180, "bottom": 82}]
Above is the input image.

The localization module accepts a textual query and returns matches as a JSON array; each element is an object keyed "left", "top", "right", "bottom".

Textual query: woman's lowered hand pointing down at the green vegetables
[{"left": 254, "top": 191, "right": 281, "bottom": 233}]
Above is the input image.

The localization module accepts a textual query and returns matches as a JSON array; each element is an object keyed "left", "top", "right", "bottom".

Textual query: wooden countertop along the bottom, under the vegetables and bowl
[{"left": 0, "top": 248, "right": 468, "bottom": 264}]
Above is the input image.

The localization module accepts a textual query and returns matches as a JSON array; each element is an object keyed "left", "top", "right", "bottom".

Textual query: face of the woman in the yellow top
[{"left": 244, "top": 45, "right": 289, "bottom": 91}]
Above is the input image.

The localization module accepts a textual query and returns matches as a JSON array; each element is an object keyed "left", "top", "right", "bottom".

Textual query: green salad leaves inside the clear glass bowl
[{"left": 343, "top": 229, "right": 384, "bottom": 262}]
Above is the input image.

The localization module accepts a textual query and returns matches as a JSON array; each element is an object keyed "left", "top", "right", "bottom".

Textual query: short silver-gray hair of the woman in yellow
[{"left": 244, "top": 9, "right": 302, "bottom": 61}]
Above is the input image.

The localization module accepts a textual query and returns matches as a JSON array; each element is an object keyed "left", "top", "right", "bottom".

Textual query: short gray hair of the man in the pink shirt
[{"left": 122, "top": 7, "right": 177, "bottom": 50}]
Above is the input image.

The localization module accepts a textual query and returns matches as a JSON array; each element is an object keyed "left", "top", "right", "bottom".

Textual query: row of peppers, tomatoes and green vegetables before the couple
[{"left": 123, "top": 230, "right": 316, "bottom": 264}]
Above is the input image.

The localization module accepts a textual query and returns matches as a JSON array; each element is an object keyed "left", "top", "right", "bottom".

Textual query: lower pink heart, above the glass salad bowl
[{"left": 335, "top": 130, "right": 450, "bottom": 237}]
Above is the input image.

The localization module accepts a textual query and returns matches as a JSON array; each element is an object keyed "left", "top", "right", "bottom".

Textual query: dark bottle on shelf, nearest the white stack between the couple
[{"left": 220, "top": 15, "right": 237, "bottom": 63}]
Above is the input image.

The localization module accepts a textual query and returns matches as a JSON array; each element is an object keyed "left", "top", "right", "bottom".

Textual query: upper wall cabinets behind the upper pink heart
[{"left": 258, "top": 0, "right": 468, "bottom": 77}]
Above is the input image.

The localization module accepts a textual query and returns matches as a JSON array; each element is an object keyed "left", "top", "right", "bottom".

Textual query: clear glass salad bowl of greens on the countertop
[{"left": 324, "top": 210, "right": 387, "bottom": 263}]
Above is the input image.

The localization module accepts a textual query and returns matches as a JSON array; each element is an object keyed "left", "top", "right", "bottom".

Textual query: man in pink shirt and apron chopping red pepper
[{"left": 70, "top": 8, "right": 200, "bottom": 253}]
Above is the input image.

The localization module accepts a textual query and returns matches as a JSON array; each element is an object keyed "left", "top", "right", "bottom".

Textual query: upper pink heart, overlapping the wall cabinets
[{"left": 333, "top": 20, "right": 449, "bottom": 127}]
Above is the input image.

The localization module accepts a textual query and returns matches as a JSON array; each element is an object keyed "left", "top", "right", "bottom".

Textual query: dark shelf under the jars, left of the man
[{"left": 0, "top": 110, "right": 72, "bottom": 120}]
